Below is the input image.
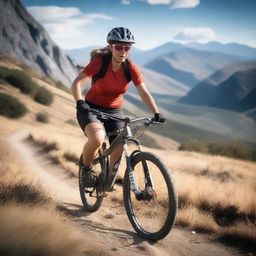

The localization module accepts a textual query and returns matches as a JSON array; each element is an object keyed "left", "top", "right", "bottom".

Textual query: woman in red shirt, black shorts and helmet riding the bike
[{"left": 71, "top": 27, "right": 165, "bottom": 187}]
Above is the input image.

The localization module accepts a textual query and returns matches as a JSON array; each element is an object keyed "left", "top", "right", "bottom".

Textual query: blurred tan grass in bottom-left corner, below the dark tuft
[{"left": 0, "top": 206, "right": 109, "bottom": 256}]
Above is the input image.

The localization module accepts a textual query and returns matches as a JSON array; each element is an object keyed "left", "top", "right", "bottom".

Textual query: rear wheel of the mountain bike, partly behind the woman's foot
[{"left": 79, "top": 158, "right": 103, "bottom": 212}]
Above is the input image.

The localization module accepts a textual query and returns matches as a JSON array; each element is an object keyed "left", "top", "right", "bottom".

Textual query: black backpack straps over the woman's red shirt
[{"left": 92, "top": 54, "right": 132, "bottom": 84}]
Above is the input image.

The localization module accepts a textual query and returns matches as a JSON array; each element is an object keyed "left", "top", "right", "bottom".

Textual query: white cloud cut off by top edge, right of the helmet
[{"left": 139, "top": 0, "right": 200, "bottom": 9}]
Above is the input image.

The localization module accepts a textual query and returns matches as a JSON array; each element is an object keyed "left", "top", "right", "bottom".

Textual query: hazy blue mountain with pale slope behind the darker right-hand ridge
[{"left": 144, "top": 48, "right": 244, "bottom": 88}]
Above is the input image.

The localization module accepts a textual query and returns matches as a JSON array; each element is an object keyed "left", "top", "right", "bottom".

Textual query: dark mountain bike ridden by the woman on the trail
[{"left": 79, "top": 109, "right": 178, "bottom": 240}]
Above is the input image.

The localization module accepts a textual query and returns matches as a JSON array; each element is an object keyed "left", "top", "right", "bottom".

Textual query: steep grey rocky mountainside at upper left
[{"left": 0, "top": 0, "right": 77, "bottom": 86}]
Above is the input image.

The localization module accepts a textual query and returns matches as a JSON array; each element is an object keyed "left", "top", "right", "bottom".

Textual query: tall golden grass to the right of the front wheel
[{"left": 29, "top": 132, "right": 256, "bottom": 246}]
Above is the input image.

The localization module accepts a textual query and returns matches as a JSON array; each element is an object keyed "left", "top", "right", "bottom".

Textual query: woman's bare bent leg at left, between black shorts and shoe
[{"left": 83, "top": 122, "right": 105, "bottom": 167}]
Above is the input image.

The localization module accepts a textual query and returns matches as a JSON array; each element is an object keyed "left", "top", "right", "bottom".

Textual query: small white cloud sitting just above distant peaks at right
[{"left": 174, "top": 28, "right": 215, "bottom": 42}]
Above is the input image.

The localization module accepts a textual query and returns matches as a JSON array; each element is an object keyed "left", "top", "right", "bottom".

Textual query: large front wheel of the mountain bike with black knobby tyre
[{"left": 123, "top": 152, "right": 178, "bottom": 240}]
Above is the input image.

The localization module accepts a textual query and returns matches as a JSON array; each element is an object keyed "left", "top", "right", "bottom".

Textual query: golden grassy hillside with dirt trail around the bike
[{"left": 0, "top": 48, "right": 256, "bottom": 256}]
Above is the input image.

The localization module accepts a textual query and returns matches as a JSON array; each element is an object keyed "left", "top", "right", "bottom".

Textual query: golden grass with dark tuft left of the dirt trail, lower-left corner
[{"left": 0, "top": 141, "right": 113, "bottom": 256}]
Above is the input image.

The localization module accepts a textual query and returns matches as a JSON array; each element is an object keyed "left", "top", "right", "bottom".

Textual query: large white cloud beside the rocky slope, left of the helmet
[{"left": 27, "top": 6, "right": 114, "bottom": 49}]
